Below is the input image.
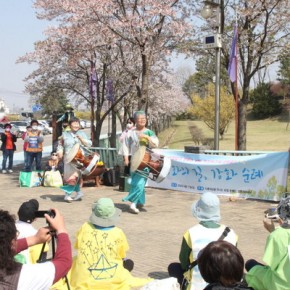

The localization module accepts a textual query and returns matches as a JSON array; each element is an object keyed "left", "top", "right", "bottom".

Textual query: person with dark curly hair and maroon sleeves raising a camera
[{"left": 0, "top": 209, "right": 72, "bottom": 290}]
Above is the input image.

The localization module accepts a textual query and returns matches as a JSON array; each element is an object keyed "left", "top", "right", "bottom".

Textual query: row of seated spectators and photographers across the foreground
[{"left": 0, "top": 192, "right": 290, "bottom": 290}]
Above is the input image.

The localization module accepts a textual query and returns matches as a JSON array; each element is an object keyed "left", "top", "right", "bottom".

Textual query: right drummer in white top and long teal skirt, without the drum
[{"left": 123, "top": 111, "right": 159, "bottom": 214}]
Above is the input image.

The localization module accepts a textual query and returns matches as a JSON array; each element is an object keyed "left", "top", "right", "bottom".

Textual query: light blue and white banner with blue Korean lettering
[{"left": 147, "top": 149, "right": 289, "bottom": 200}]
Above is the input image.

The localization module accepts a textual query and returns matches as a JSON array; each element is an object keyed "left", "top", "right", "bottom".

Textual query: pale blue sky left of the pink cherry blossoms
[{"left": 0, "top": 0, "right": 47, "bottom": 110}]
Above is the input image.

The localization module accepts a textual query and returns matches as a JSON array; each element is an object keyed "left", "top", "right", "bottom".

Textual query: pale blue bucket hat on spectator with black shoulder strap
[{"left": 191, "top": 192, "right": 221, "bottom": 222}]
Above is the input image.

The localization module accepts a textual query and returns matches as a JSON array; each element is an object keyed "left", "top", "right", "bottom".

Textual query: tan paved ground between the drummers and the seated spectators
[{"left": 0, "top": 167, "right": 271, "bottom": 286}]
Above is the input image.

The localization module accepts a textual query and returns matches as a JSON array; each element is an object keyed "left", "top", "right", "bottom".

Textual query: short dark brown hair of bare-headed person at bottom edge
[{"left": 198, "top": 241, "right": 244, "bottom": 287}]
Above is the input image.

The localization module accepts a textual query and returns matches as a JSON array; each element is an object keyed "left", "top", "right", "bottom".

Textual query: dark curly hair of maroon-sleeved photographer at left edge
[{"left": 0, "top": 210, "right": 17, "bottom": 279}]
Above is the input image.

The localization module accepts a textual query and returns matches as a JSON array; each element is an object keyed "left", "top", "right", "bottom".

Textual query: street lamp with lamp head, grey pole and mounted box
[{"left": 201, "top": 0, "right": 223, "bottom": 150}]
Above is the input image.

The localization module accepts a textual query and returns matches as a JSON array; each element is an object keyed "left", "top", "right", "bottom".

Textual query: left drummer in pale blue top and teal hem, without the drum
[{"left": 57, "top": 118, "right": 92, "bottom": 202}]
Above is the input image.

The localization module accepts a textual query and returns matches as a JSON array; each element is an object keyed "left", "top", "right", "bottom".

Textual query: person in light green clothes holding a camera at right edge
[{"left": 245, "top": 196, "right": 290, "bottom": 290}]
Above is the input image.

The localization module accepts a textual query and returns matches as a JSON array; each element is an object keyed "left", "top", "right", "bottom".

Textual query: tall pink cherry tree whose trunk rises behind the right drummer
[{"left": 35, "top": 0, "right": 194, "bottom": 109}]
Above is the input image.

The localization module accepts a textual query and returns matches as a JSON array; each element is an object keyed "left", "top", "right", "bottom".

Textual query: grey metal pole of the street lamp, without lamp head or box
[{"left": 214, "top": 1, "right": 222, "bottom": 150}]
